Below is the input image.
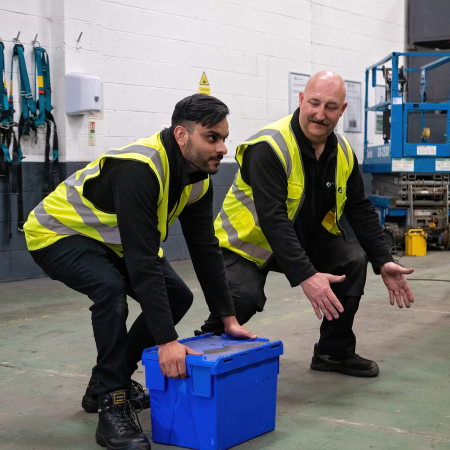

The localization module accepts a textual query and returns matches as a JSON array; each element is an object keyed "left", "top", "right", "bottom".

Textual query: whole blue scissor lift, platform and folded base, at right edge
[{"left": 363, "top": 52, "right": 450, "bottom": 249}]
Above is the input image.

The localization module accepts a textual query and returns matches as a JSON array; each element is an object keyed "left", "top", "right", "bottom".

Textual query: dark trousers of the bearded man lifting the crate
[{"left": 31, "top": 236, "right": 193, "bottom": 396}]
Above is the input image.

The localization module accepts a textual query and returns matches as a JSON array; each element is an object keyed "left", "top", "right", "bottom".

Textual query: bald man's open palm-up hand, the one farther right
[{"left": 380, "top": 262, "right": 414, "bottom": 308}]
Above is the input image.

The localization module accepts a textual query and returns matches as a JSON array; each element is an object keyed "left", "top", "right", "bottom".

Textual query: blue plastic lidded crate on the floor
[{"left": 142, "top": 334, "right": 283, "bottom": 450}]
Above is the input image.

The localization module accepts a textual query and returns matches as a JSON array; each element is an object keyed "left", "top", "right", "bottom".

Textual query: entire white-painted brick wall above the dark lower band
[{"left": 0, "top": 0, "right": 405, "bottom": 161}]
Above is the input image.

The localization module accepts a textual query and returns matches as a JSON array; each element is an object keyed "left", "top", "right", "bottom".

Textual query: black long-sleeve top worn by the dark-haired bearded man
[{"left": 83, "top": 128, "right": 235, "bottom": 344}]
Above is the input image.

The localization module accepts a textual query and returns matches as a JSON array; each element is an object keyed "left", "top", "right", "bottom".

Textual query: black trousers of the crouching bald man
[{"left": 202, "top": 232, "right": 367, "bottom": 360}]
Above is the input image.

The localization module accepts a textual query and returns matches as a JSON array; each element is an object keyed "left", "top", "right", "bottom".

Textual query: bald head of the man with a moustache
[{"left": 299, "top": 70, "right": 347, "bottom": 145}]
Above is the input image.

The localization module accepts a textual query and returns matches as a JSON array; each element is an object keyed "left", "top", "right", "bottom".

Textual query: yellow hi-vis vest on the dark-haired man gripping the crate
[{"left": 24, "top": 133, "right": 210, "bottom": 257}]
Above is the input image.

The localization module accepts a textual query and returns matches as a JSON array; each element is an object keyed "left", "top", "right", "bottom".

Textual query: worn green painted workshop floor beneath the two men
[{"left": 0, "top": 251, "right": 450, "bottom": 450}]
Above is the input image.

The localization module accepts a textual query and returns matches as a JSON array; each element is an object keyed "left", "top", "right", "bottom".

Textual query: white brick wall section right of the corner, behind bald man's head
[{"left": 311, "top": 0, "right": 406, "bottom": 162}]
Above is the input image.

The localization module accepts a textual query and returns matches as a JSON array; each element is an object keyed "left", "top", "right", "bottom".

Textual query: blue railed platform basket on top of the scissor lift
[{"left": 363, "top": 52, "right": 450, "bottom": 173}]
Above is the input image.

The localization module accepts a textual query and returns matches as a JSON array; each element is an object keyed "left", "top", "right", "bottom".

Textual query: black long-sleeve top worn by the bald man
[{"left": 241, "top": 109, "right": 393, "bottom": 287}]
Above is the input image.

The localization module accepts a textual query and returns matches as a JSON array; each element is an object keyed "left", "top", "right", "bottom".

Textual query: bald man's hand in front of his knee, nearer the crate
[{"left": 300, "top": 272, "right": 345, "bottom": 320}]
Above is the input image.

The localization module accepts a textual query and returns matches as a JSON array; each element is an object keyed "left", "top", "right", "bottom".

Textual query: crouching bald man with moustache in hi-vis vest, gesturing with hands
[{"left": 198, "top": 71, "right": 414, "bottom": 377}]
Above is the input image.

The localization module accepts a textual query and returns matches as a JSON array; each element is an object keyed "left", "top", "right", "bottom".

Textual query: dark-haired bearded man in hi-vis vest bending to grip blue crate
[{"left": 24, "top": 94, "right": 256, "bottom": 450}]
